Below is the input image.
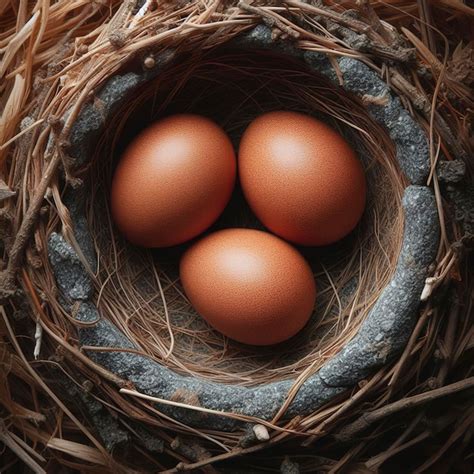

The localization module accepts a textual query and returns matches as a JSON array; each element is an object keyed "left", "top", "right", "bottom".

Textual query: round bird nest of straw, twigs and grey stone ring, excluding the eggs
[{"left": 0, "top": 1, "right": 473, "bottom": 472}]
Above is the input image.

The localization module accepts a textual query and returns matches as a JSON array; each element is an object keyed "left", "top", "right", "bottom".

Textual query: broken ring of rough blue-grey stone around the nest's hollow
[{"left": 49, "top": 26, "right": 439, "bottom": 430}]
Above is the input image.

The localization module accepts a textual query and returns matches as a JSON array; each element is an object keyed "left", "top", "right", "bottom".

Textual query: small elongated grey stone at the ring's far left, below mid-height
[{"left": 48, "top": 232, "right": 94, "bottom": 301}]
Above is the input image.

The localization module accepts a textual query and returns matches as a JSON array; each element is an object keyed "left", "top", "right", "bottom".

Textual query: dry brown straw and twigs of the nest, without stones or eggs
[{"left": 0, "top": 0, "right": 474, "bottom": 472}]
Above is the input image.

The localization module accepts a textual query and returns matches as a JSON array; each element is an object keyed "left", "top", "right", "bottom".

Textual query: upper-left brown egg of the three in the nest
[{"left": 111, "top": 114, "right": 236, "bottom": 247}]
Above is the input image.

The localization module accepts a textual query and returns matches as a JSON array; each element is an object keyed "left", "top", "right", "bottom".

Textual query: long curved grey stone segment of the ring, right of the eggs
[{"left": 320, "top": 186, "right": 439, "bottom": 387}]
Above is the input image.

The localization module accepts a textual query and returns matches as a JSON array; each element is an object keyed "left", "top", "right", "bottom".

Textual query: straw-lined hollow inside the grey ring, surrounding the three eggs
[{"left": 85, "top": 48, "right": 406, "bottom": 385}]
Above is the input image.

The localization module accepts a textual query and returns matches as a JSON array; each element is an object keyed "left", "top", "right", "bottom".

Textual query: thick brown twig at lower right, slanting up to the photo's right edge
[{"left": 335, "top": 376, "right": 474, "bottom": 441}]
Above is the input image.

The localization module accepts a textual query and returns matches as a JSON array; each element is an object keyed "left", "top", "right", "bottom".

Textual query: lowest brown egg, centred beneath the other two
[{"left": 180, "top": 229, "right": 316, "bottom": 345}]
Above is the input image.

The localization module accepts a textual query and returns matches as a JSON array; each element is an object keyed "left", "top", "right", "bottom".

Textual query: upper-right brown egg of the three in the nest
[{"left": 238, "top": 112, "right": 366, "bottom": 245}]
